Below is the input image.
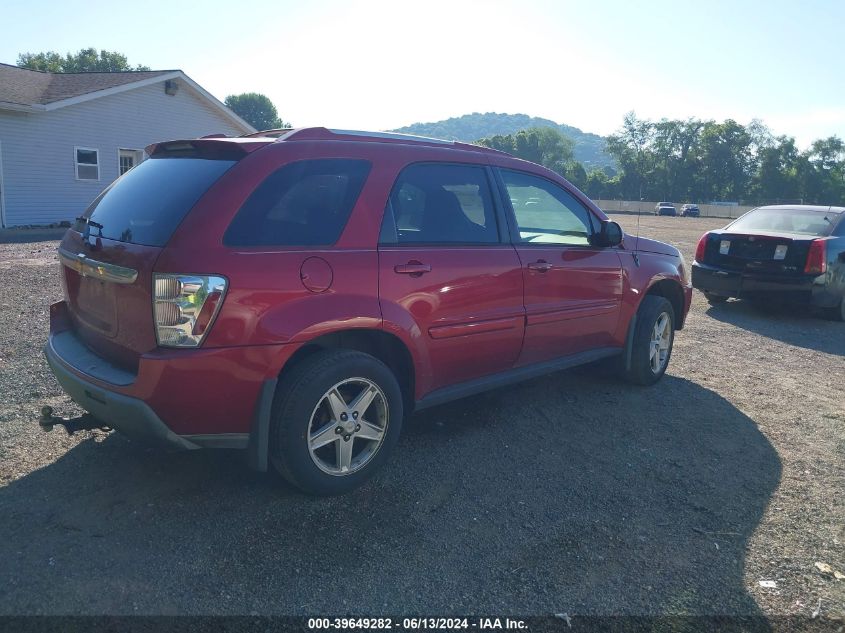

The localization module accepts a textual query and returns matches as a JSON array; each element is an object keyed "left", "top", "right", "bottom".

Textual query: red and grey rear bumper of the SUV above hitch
[{"left": 44, "top": 302, "right": 295, "bottom": 449}]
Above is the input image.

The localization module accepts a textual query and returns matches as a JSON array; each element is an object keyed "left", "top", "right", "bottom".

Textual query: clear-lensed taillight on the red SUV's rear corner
[{"left": 153, "top": 274, "right": 226, "bottom": 347}]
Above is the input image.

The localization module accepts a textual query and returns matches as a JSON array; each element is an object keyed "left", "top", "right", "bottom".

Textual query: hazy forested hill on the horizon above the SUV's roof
[{"left": 392, "top": 112, "right": 615, "bottom": 171}]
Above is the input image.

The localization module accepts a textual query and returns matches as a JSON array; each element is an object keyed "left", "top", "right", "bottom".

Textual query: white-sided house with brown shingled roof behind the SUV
[{"left": 0, "top": 64, "right": 255, "bottom": 227}]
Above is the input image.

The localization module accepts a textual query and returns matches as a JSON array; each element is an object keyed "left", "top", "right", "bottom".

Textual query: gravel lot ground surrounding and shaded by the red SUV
[{"left": 0, "top": 216, "right": 845, "bottom": 626}]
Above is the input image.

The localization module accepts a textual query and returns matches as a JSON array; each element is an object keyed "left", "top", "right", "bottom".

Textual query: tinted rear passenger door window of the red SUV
[{"left": 380, "top": 163, "right": 499, "bottom": 244}]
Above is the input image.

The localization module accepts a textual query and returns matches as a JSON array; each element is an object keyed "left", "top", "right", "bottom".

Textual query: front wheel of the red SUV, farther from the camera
[{"left": 623, "top": 295, "right": 675, "bottom": 385}]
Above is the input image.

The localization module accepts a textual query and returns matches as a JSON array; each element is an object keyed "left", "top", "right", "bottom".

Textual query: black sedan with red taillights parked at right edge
[{"left": 692, "top": 205, "right": 845, "bottom": 321}]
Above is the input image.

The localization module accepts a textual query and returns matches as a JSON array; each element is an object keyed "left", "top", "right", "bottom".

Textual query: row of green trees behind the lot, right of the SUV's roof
[{"left": 478, "top": 112, "right": 845, "bottom": 205}]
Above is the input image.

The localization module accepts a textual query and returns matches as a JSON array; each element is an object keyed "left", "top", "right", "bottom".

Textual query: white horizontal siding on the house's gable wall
[{"left": 0, "top": 81, "right": 249, "bottom": 226}]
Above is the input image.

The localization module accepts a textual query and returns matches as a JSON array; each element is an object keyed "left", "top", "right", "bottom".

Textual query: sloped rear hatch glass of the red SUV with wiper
[{"left": 74, "top": 158, "right": 235, "bottom": 246}]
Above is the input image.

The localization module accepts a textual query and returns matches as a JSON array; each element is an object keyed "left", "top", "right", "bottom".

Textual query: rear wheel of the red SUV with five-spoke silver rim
[{"left": 270, "top": 350, "right": 404, "bottom": 495}]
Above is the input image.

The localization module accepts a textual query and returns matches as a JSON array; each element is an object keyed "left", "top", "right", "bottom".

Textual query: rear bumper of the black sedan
[{"left": 692, "top": 262, "right": 839, "bottom": 308}]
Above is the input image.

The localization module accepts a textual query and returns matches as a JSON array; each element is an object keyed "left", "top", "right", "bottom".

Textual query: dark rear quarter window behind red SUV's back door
[{"left": 223, "top": 158, "right": 370, "bottom": 246}]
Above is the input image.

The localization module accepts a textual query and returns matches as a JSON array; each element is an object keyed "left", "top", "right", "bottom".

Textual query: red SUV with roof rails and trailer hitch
[{"left": 45, "top": 128, "right": 691, "bottom": 494}]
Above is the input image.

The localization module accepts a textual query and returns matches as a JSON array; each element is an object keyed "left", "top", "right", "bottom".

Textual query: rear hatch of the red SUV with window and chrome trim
[{"left": 59, "top": 140, "right": 263, "bottom": 371}]
